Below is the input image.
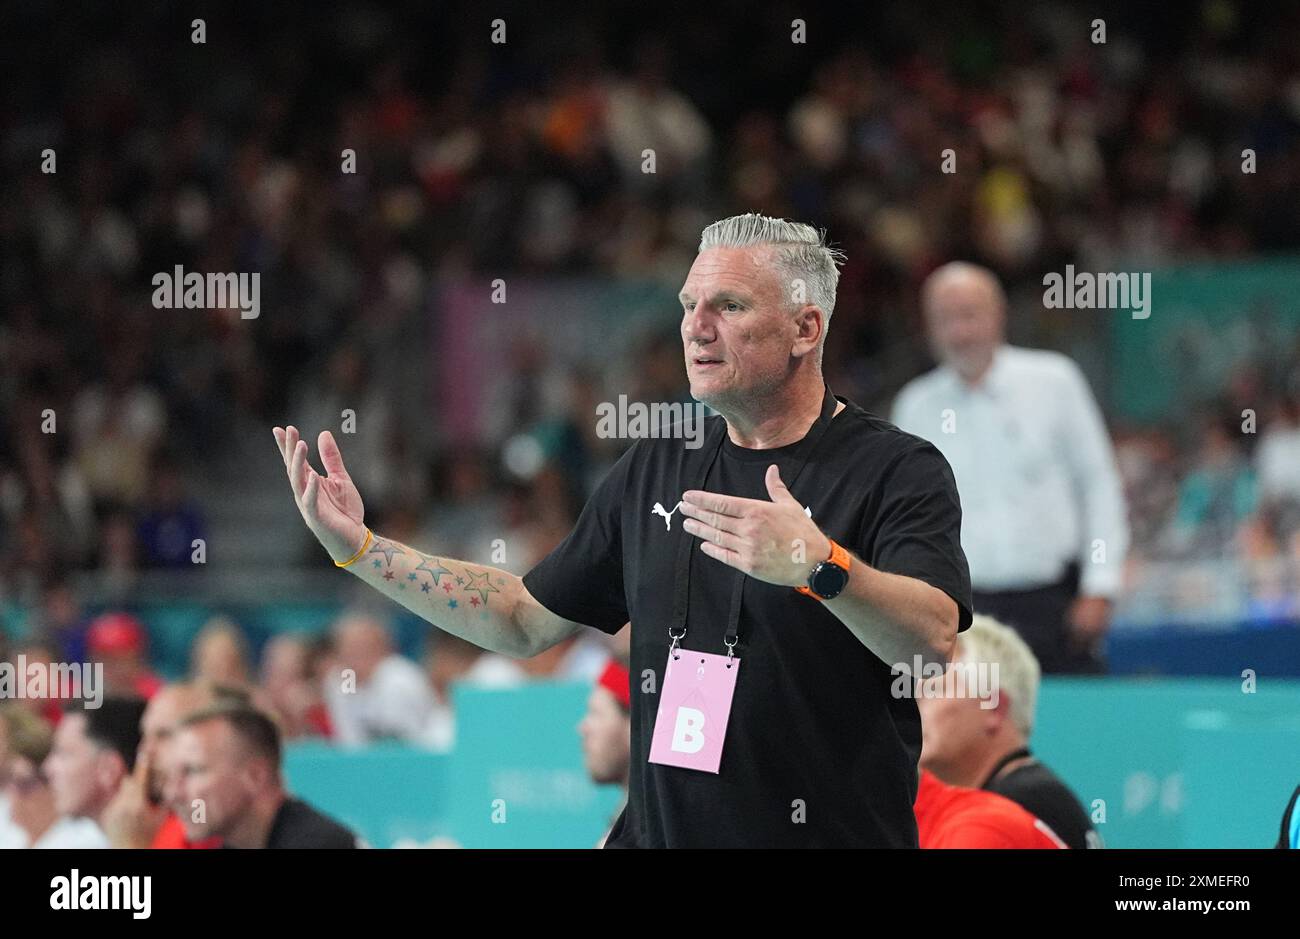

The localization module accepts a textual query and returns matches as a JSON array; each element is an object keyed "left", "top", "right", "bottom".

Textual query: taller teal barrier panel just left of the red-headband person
[{"left": 447, "top": 683, "right": 621, "bottom": 848}]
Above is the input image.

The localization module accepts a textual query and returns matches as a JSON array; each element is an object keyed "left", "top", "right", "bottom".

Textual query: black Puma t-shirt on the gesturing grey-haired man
[{"left": 524, "top": 387, "right": 971, "bottom": 847}]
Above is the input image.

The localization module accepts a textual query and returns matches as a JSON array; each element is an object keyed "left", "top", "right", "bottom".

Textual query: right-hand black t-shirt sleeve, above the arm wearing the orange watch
[{"left": 858, "top": 440, "right": 971, "bottom": 632}]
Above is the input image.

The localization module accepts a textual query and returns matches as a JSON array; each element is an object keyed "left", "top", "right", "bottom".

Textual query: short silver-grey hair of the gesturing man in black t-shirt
[{"left": 699, "top": 212, "right": 844, "bottom": 323}]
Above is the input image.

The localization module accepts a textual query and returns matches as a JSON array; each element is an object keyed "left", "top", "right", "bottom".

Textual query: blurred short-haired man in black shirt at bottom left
[{"left": 174, "top": 705, "right": 360, "bottom": 848}]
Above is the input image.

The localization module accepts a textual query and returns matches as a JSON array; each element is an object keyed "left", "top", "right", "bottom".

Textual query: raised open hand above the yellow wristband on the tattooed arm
[{"left": 273, "top": 425, "right": 365, "bottom": 561}]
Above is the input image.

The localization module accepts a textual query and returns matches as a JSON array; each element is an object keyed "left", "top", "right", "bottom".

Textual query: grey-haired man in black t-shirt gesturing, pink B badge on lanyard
[{"left": 274, "top": 215, "right": 970, "bottom": 847}]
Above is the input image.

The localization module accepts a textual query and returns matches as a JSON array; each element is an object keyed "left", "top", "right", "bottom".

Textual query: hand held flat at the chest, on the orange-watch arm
[{"left": 681, "top": 463, "right": 831, "bottom": 587}]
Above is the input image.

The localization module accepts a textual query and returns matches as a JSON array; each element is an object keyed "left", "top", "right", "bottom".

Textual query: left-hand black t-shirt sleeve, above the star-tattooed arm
[{"left": 524, "top": 443, "right": 638, "bottom": 636}]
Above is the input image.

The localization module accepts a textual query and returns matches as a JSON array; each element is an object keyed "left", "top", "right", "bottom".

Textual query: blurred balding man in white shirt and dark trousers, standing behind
[{"left": 892, "top": 261, "right": 1128, "bottom": 674}]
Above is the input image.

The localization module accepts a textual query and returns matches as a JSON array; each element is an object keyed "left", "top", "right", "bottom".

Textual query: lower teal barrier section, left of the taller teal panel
[{"left": 285, "top": 743, "right": 449, "bottom": 848}]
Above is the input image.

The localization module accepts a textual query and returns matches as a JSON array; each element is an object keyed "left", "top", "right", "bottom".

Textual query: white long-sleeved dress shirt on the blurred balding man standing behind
[{"left": 892, "top": 345, "right": 1128, "bottom": 597}]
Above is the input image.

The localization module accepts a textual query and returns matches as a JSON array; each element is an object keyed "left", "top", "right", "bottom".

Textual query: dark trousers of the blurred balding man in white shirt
[{"left": 971, "top": 564, "right": 1106, "bottom": 675}]
